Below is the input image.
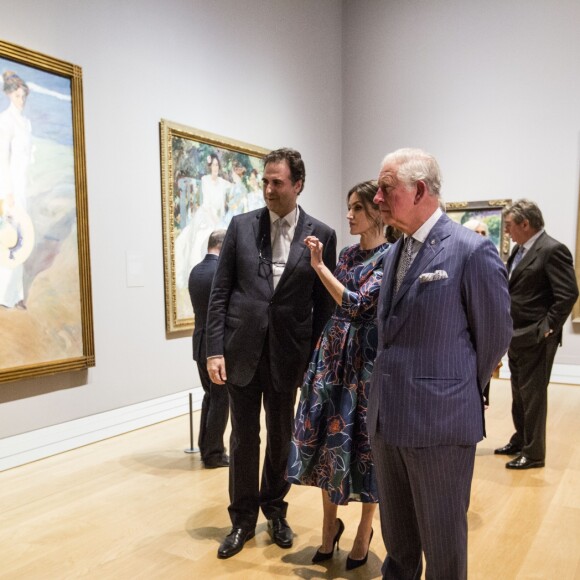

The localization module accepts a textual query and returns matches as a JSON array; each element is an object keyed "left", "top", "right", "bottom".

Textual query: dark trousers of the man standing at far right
[{"left": 508, "top": 336, "right": 558, "bottom": 461}]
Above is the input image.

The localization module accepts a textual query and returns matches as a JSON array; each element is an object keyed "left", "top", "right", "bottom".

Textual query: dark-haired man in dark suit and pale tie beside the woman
[{"left": 207, "top": 149, "right": 336, "bottom": 558}]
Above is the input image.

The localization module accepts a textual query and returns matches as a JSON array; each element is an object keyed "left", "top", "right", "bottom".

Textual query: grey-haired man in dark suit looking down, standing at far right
[{"left": 495, "top": 199, "right": 578, "bottom": 469}]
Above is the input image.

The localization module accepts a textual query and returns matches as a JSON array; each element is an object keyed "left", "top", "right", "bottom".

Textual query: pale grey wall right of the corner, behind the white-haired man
[{"left": 343, "top": 0, "right": 580, "bottom": 362}]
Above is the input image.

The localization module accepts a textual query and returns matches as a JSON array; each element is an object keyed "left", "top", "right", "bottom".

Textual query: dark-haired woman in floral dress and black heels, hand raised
[{"left": 287, "top": 181, "right": 389, "bottom": 569}]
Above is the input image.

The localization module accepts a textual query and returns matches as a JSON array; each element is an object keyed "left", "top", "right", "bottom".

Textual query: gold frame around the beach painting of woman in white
[{"left": 0, "top": 41, "right": 95, "bottom": 383}]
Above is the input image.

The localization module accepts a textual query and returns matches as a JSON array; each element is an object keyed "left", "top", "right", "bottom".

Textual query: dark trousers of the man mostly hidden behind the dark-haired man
[{"left": 197, "top": 362, "right": 229, "bottom": 464}]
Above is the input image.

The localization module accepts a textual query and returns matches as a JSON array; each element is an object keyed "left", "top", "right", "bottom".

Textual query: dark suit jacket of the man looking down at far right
[{"left": 508, "top": 232, "right": 578, "bottom": 347}]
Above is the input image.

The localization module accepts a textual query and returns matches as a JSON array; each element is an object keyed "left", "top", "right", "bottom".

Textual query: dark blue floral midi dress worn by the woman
[{"left": 286, "top": 243, "right": 389, "bottom": 505}]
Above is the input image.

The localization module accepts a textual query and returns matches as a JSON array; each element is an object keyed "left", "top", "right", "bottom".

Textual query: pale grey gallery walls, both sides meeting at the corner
[{"left": 0, "top": 0, "right": 580, "bottom": 438}]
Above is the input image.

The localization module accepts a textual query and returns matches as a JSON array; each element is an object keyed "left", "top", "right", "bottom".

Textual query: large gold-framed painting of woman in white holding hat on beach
[{"left": 0, "top": 41, "right": 95, "bottom": 382}]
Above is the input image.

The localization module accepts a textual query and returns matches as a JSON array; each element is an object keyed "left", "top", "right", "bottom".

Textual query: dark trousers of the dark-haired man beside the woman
[{"left": 227, "top": 348, "right": 297, "bottom": 530}]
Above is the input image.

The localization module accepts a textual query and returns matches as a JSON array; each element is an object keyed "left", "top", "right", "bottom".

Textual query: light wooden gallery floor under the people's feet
[{"left": 0, "top": 380, "right": 580, "bottom": 580}]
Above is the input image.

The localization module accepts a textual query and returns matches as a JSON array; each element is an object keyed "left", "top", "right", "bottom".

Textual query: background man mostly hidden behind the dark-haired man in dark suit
[{"left": 189, "top": 230, "right": 230, "bottom": 469}]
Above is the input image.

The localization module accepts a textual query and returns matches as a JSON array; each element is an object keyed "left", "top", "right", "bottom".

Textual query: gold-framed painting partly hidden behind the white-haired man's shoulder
[{"left": 445, "top": 199, "right": 511, "bottom": 263}]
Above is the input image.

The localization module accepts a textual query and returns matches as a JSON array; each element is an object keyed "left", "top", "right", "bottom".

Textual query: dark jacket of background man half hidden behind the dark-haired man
[{"left": 189, "top": 254, "right": 218, "bottom": 363}]
